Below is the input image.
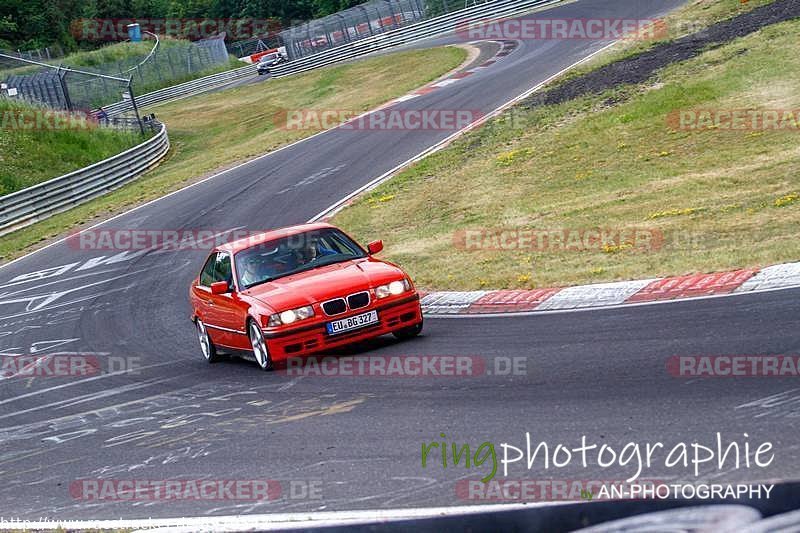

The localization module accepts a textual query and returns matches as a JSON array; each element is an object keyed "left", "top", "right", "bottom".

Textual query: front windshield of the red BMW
[{"left": 234, "top": 228, "right": 367, "bottom": 289}]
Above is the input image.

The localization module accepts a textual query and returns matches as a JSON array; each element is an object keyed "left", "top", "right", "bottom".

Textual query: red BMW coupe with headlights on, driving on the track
[{"left": 189, "top": 223, "right": 422, "bottom": 370}]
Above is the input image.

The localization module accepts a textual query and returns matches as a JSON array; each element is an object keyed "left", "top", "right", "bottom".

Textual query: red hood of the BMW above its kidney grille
[{"left": 242, "top": 258, "right": 405, "bottom": 312}]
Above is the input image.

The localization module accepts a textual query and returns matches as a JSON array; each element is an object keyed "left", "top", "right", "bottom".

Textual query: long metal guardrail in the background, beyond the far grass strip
[{"left": 103, "top": 0, "right": 563, "bottom": 115}]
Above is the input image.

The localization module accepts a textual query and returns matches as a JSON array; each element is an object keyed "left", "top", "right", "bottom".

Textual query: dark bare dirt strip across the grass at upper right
[{"left": 520, "top": 0, "right": 800, "bottom": 109}]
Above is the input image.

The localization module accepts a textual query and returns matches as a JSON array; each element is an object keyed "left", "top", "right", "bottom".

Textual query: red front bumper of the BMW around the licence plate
[{"left": 264, "top": 294, "right": 422, "bottom": 361}]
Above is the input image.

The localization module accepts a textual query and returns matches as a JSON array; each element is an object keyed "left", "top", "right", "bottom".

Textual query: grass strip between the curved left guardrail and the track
[{"left": 0, "top": 47, "right": 467, "bottom": 261}]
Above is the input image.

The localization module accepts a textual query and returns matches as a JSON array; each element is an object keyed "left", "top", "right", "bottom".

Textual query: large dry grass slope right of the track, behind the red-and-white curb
[{"left": 334, "top": 1, "right": 800, "bottom": 290}]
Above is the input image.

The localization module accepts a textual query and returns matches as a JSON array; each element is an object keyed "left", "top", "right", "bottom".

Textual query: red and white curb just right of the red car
[{"left": 422, "top": 263, "right": 800, "bottom": 315}]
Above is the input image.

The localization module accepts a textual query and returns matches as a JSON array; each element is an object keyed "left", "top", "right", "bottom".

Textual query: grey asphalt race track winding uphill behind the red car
[{"left": 0, "top": 0, "right": 800, "bottom": 519}]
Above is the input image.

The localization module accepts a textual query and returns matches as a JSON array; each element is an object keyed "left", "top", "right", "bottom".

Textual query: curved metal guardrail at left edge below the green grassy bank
[{"left": 0, "top": 124, "right": 169, "bottom": 235}]
